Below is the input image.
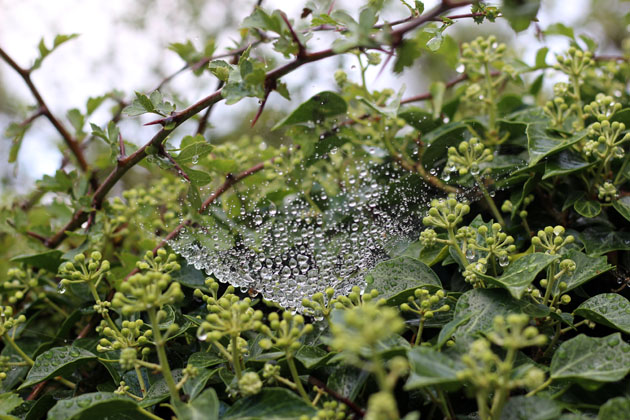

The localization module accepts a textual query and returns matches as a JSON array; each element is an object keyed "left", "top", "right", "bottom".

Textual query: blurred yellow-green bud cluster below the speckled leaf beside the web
[{"left": 331, "top": 302, "right": 404, "bottom": 355}]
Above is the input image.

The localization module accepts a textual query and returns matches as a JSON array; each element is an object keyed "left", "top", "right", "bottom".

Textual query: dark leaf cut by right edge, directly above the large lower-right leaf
[{"left": 573, "top": 293, "right": 630, "bottom": 334}]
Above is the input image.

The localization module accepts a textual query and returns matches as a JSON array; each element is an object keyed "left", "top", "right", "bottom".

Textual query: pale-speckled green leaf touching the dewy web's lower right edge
[{"left": 365, "top": 257, "right": 442, "bottom": 305}]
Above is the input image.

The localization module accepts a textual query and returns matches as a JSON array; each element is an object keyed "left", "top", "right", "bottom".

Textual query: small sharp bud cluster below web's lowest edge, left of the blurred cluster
[{"left": 259, "top": 311, "right": 313, "bottom": 355}]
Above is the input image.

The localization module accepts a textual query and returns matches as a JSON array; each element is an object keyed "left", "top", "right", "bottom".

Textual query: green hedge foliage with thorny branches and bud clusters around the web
[{"left": 0, "top": 0, "right": 630, "bottom": 420}]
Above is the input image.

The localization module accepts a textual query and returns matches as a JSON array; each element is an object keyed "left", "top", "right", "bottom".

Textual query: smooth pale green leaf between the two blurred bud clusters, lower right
[{"left": 405, "top": 346, "right": 466, "bottom": 390}]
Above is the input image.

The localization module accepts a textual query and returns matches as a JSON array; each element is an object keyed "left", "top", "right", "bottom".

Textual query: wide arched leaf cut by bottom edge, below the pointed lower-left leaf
[{"left": 47, "top": 392, "right": 147, "bottom": 420}]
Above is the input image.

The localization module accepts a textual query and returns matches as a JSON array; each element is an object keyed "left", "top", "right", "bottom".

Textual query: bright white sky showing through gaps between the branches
[{"left": 0, "top": 0, "right": 588, "bottom": 192}]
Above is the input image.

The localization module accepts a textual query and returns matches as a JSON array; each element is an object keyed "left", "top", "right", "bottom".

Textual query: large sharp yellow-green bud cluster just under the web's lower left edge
[{"left": 194, "top": 278, "right": 263, "bottom": 342}]
